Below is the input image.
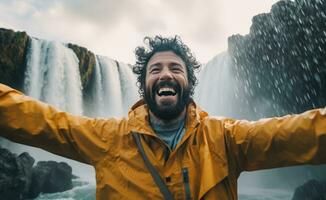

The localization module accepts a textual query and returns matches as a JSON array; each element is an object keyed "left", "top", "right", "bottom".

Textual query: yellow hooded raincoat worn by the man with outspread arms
[{"left": 0, "top": 84, "right": 326, "bottom": 200}]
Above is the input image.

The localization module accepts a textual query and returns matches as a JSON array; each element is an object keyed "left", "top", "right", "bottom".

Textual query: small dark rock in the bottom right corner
[{"left": 292, "top": 180, "right": 326, "bottom": 200}]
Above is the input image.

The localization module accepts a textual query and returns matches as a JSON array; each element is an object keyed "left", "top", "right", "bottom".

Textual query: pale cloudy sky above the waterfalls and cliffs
[{"left": 0, "top": 0, "right": 277, "bottom": 64}]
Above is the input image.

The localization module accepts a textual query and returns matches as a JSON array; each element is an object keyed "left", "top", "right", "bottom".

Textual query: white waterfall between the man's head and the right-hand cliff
[{"left": 195, "top": 52, "right": 240, "bottom": 117}]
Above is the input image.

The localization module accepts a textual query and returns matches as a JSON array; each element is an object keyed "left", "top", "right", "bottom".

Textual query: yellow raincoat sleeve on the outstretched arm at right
[{"left": 224, "top": 108, "right": 326, "bottom": 172}]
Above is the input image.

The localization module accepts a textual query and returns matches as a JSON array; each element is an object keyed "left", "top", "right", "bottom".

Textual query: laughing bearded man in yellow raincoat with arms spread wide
[{"left": 0, "top": 36, "right": 326, "bottom": 200}]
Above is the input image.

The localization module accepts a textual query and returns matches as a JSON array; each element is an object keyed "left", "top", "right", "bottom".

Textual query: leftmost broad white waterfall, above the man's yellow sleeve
[{"left": 24, "top": 38, "right": 83, "bottom": 115}]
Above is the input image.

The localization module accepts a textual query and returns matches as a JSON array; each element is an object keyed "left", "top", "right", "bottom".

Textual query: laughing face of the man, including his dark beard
[{"left": 145, "top": 51, "right": 190, "bottom": 120}]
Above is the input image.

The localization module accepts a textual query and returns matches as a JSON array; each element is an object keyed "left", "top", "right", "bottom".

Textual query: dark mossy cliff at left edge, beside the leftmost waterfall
[{"left": 0, "top": 28, "right": 30, "bottom": 89}]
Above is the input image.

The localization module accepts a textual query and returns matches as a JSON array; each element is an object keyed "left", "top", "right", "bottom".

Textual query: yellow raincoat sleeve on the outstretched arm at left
[{"left": 0, "top": 84, "right": 121, "bottom": 164}]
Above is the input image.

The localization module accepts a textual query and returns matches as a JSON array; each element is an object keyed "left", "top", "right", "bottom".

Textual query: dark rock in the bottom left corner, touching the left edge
[{"left": 0, "top": 148, "right": 34, "bottom": 199}]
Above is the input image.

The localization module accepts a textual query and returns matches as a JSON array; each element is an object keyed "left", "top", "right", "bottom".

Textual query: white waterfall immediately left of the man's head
[{"left": 85, "top": 56, "right": 139, "bottom": 117}]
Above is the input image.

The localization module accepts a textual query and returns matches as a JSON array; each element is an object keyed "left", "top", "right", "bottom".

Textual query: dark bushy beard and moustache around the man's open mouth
[{"left": 144, "top": 81, "right": 190, "bottom": 120}]
